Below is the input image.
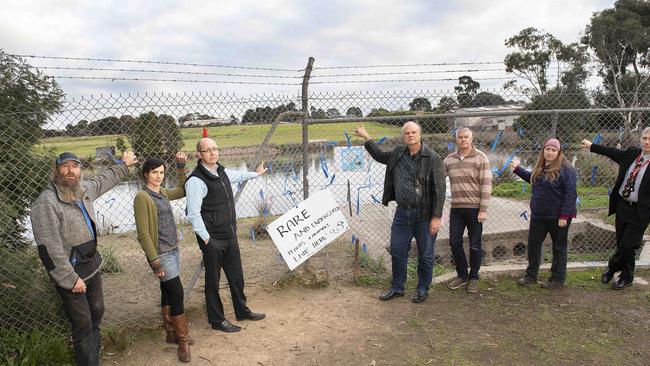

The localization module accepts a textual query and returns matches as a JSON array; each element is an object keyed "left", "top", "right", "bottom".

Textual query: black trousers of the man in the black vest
[{"left": 198, "top": 234, "right": 251, "bottom": 324}]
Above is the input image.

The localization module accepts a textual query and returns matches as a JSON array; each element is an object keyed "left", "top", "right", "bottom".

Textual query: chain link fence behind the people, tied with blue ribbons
[{"left": 0, "top": 91, "right": 650, "bottom": 333}]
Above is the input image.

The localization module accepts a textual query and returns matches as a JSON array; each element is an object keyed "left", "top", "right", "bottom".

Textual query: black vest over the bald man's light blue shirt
[{"left": 190, "top": 160, "right": 237, "bottom": 239}]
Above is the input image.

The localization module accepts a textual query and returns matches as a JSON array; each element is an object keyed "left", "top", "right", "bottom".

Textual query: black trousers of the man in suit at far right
[{"left": 609, "top": 199, "right": 648, "bottom": 280}]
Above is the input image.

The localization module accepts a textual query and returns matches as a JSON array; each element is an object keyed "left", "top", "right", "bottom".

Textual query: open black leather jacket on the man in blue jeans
[{"left": 364, "top": 141, "right": 447, "bottom": 220}]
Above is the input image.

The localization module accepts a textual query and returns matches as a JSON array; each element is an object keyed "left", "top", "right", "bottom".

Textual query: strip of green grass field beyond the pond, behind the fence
[{"left": 34, "top": 122, "right": 401, "bottom": 158}]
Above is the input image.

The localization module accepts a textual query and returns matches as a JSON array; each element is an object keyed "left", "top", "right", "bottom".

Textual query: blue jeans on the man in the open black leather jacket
[{"left": 390, "top": 207, "right": 436, "bottom": 293}]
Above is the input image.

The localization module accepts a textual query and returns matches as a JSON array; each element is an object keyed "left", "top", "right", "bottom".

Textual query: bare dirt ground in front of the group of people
[{"left": 103, "top": 255, "right": 650, "bottom": 365}]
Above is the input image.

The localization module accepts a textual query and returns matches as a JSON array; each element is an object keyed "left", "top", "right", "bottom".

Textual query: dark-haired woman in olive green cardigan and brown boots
[{"left": 133, "top": 152, "right": 191, "bottom": 362}]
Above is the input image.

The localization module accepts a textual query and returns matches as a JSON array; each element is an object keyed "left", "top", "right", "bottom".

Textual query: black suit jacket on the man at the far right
[{"left": 589, "top": 144, "right": 650, "bottom": 222}]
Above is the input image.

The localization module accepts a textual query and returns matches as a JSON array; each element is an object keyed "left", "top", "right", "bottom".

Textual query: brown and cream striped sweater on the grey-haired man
[{"left": 445, "top": 148, "right": 492, "bottom": 212}]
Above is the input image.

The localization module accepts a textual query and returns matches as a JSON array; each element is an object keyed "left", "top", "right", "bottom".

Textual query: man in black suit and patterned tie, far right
[{"left": 582, "top": 127, "right": 650, "bottom": 290}]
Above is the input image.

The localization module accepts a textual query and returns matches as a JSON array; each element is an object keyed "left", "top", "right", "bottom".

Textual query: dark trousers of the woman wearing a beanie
[{"left": 526, "top": 219, "right": 571, "bottom": 283}]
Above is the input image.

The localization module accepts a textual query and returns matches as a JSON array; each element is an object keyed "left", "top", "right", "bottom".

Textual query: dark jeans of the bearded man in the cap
[{"left": 56, "top": 273, "right": 104, "bottom": 366}]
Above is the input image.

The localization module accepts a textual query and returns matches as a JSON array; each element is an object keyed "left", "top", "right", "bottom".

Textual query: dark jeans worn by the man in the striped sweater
[{"left": 449, "top": 208, "right": 483, "bottom": 280}]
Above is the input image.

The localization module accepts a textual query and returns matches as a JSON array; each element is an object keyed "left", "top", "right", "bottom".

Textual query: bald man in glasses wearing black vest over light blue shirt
[{"left": 185, "top": 137, "right": 267, "bottom": 332}]
